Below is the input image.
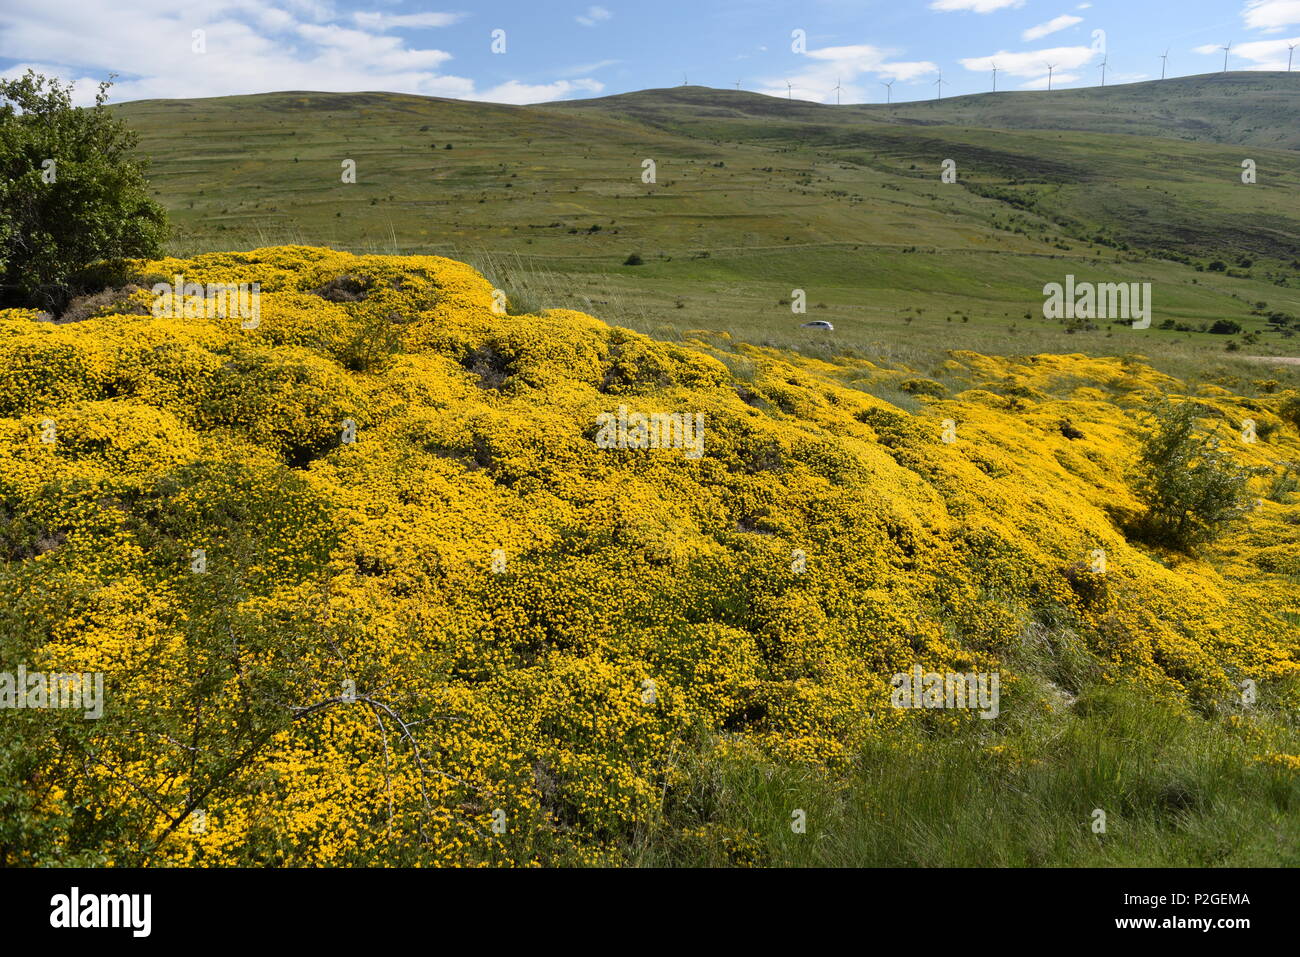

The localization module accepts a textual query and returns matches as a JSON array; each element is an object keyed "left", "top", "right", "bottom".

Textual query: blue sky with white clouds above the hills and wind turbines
[{"left": 0, "top": 0, "right": 1300, "bottom": 103}]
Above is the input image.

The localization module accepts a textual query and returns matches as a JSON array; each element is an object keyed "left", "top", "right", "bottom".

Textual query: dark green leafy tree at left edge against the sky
[{"left": 0, "top": 70, "right": 166, "bottom": 309}]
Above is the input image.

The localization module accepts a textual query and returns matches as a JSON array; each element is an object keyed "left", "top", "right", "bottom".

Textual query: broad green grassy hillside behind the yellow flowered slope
[{"left": 109, "top": 74, "right": 1300, "bottom": 390}]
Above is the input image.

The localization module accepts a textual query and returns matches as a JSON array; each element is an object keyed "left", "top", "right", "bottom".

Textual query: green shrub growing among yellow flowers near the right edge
[{"left": 1135, "top": 402, "right": 1258, "bottom": 551}]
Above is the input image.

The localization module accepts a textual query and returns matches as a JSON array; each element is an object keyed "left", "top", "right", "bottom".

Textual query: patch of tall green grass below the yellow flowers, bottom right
[{"left": 632, "top": 685, "right": 1300, "bottom": 867}]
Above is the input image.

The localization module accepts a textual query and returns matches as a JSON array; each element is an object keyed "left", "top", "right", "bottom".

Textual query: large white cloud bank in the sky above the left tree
[{"left": 0, "top": 0, "right": 603, "bottom": 104}]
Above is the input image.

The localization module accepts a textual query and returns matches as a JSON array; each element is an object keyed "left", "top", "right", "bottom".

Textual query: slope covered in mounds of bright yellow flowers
[{"left": 0, "top": 247, "right": 1300, "bottom": 865}]
